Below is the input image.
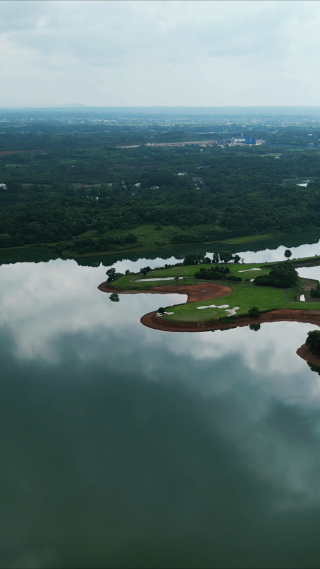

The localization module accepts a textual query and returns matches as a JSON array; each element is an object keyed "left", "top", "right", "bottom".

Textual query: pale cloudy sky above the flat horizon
[{"left": 0, "top": 0, "right": 320, "bottom": 107}]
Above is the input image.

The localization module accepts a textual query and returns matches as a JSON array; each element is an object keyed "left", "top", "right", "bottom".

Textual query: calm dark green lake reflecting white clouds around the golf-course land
[{"left": 0, "top": 236, "right": 320, "bottom": 568}]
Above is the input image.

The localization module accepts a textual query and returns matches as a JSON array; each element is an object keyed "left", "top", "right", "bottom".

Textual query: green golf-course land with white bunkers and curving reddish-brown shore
[{"left": 98, "top": 251, "right": 320, "bottom": 340}]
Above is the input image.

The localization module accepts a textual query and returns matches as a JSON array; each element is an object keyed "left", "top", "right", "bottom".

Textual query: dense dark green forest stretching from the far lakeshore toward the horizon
[{"left": 0, "top": 109, "right": 320, "bottom": 254}]
